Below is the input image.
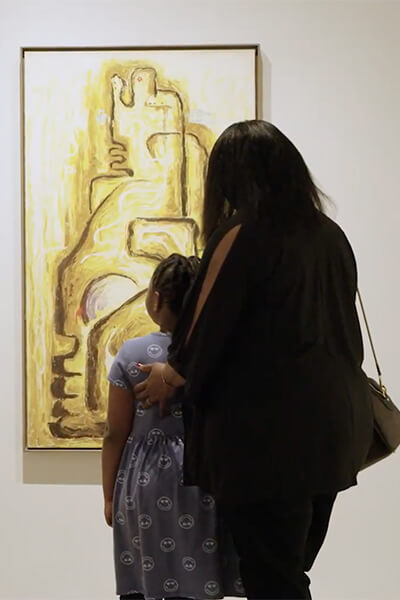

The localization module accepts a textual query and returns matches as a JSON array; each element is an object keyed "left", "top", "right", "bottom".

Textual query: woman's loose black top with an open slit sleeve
[{"left": 169, "top": 214, "right": 373, "bottom": 502}]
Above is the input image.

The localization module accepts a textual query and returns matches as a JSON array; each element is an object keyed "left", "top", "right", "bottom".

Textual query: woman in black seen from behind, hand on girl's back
[{"left": 136, "top": 121, "right": 372, "bottom": 600}]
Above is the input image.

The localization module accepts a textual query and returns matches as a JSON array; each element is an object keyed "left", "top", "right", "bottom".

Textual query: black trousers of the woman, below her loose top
[{"left": 220, "top": 494, "right": 336, "bottom": 600}]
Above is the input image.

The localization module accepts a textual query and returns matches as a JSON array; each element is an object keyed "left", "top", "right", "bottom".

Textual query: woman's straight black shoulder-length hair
[{"left": 203, "top": 120, "right": 325, "bottom": 241}]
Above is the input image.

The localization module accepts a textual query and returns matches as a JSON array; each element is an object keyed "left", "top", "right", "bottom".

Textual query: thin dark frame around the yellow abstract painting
[{"left": 20, "top": 44, "right": 262, "bottom": 452}]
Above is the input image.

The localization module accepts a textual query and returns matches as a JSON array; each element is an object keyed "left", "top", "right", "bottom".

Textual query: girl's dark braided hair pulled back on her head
[{"left": 151, "top": 254, "right": 200, "bottom": 315}]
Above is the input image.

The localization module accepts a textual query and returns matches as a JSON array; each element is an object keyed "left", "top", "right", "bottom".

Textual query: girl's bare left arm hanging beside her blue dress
[{"left": 102, "top": 384, "right": 136, "bottom": 525}]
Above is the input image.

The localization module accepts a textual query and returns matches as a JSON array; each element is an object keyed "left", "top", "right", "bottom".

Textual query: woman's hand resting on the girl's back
[{"left": 134, "top": 363, "right": 175, "bottom": 417}]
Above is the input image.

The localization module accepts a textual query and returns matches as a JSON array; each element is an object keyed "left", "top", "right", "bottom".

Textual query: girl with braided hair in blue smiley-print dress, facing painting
[{"left": 102, "top": 254, "right": 244, "bottom": 599}]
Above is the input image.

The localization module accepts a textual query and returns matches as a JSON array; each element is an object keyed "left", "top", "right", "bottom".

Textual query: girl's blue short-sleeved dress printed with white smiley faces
[{"left": 108, "top": 333, "right": 245, "bottom": 599}]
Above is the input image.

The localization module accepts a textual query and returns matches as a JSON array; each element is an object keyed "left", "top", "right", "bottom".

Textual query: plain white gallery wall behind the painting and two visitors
[{"left": 0, "top": 0, "right": 400, "bottom": 600}]
